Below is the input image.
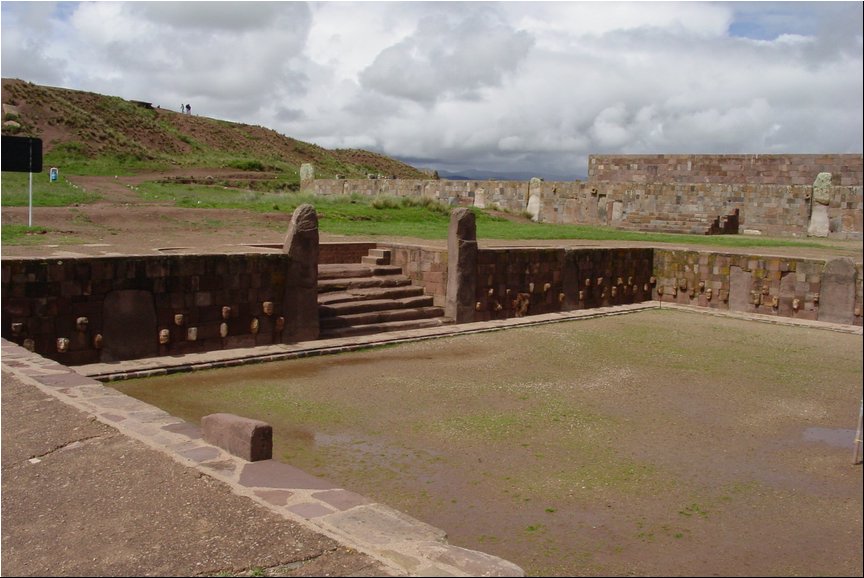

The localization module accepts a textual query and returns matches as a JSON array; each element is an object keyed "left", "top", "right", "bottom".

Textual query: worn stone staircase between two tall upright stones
[{"left": 318, "top": 249, "right": 449, "bottom": 339}]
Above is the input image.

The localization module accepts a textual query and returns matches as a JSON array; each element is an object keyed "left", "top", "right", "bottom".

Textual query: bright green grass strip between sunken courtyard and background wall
[{"left": 2, "top": 166, "right": 848, "bottom": 248}]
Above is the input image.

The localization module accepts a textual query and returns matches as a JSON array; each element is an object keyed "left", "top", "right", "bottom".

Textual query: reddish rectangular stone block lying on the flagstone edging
[{"left": 201, "top": 413, "right": 273, "bottom": 462}]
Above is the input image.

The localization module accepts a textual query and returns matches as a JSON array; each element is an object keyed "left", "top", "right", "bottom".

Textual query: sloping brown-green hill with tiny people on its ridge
[{"left": 2, "top": 78, "right": 428, "bottom": 180}]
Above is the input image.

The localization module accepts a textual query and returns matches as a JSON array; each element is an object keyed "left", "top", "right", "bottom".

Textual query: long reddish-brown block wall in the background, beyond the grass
[{"left": 308, "top": 155, "right": 864, "bottom": 239}]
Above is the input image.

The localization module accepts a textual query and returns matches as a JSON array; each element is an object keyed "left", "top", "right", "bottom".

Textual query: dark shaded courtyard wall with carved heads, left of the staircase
[{"left": 2, "top": 254, "right": 317, "bottom": 365}]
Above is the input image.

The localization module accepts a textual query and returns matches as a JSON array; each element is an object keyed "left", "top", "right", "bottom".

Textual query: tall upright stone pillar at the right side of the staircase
[{"left": 444, "top": 208, "right": 477, "bottom": 323}]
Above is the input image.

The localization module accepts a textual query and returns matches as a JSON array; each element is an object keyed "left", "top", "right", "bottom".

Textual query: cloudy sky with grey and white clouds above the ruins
[{"left": 2, "top": 1, "right": 864, "bottom": 179}]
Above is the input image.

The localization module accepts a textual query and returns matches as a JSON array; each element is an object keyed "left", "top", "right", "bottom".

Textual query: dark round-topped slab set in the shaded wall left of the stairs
[{"left": 100, "top": 289, "right": 159, "bottom": 362}]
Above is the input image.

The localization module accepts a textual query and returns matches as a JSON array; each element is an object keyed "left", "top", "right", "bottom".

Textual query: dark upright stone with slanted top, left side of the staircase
[{"left": 282, "top": 204, "right": 319, "bottom": 343}]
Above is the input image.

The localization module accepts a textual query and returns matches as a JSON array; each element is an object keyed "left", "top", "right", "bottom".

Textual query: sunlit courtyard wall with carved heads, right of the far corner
[{"left": 652, "top": 249, "right": 862, "bottom": 326}]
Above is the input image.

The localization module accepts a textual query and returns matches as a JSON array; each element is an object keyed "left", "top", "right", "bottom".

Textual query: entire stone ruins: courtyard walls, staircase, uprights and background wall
[{"left": 2, "top": 155, "right": 864, "bottom": 365}]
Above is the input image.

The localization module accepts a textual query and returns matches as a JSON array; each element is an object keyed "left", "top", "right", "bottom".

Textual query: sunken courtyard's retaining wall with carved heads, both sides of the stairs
[{"left": 2, "top": 243, "right": 864, "bottom": 365}]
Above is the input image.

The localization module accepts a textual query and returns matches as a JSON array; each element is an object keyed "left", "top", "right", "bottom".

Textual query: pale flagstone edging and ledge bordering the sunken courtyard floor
[{"left": 2, "top": 302, "right": 862, "bottom": 576}]
